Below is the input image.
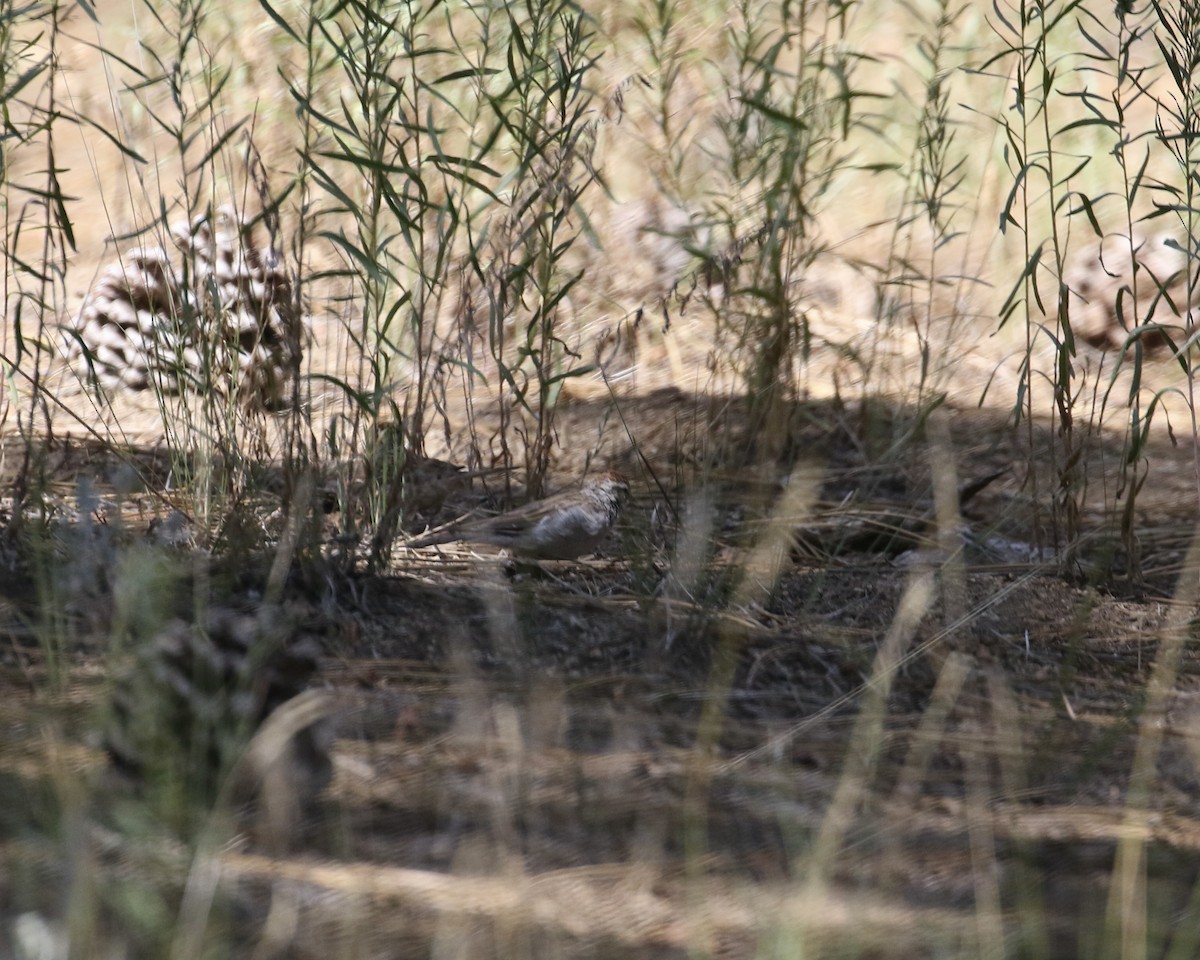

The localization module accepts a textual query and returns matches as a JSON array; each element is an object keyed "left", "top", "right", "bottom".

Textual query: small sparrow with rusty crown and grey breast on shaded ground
[{"left": 404, "top": 473, "right": 629, "bottom": 560}]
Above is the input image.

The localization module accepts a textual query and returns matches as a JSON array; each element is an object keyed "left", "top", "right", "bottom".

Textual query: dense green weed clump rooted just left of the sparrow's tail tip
[{"left": 263, "top": 0, "right": 472, "bottom": 571}]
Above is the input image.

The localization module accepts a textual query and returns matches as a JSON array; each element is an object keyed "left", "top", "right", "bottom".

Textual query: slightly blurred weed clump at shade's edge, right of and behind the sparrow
[{"left": 712, "top": 0, "right": 870, "bottom": 458}]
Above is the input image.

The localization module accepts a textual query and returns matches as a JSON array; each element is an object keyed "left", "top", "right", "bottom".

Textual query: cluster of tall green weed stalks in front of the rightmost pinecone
[{"left": 983, "top": 2, "right": 1200, "bottom": 578}]
